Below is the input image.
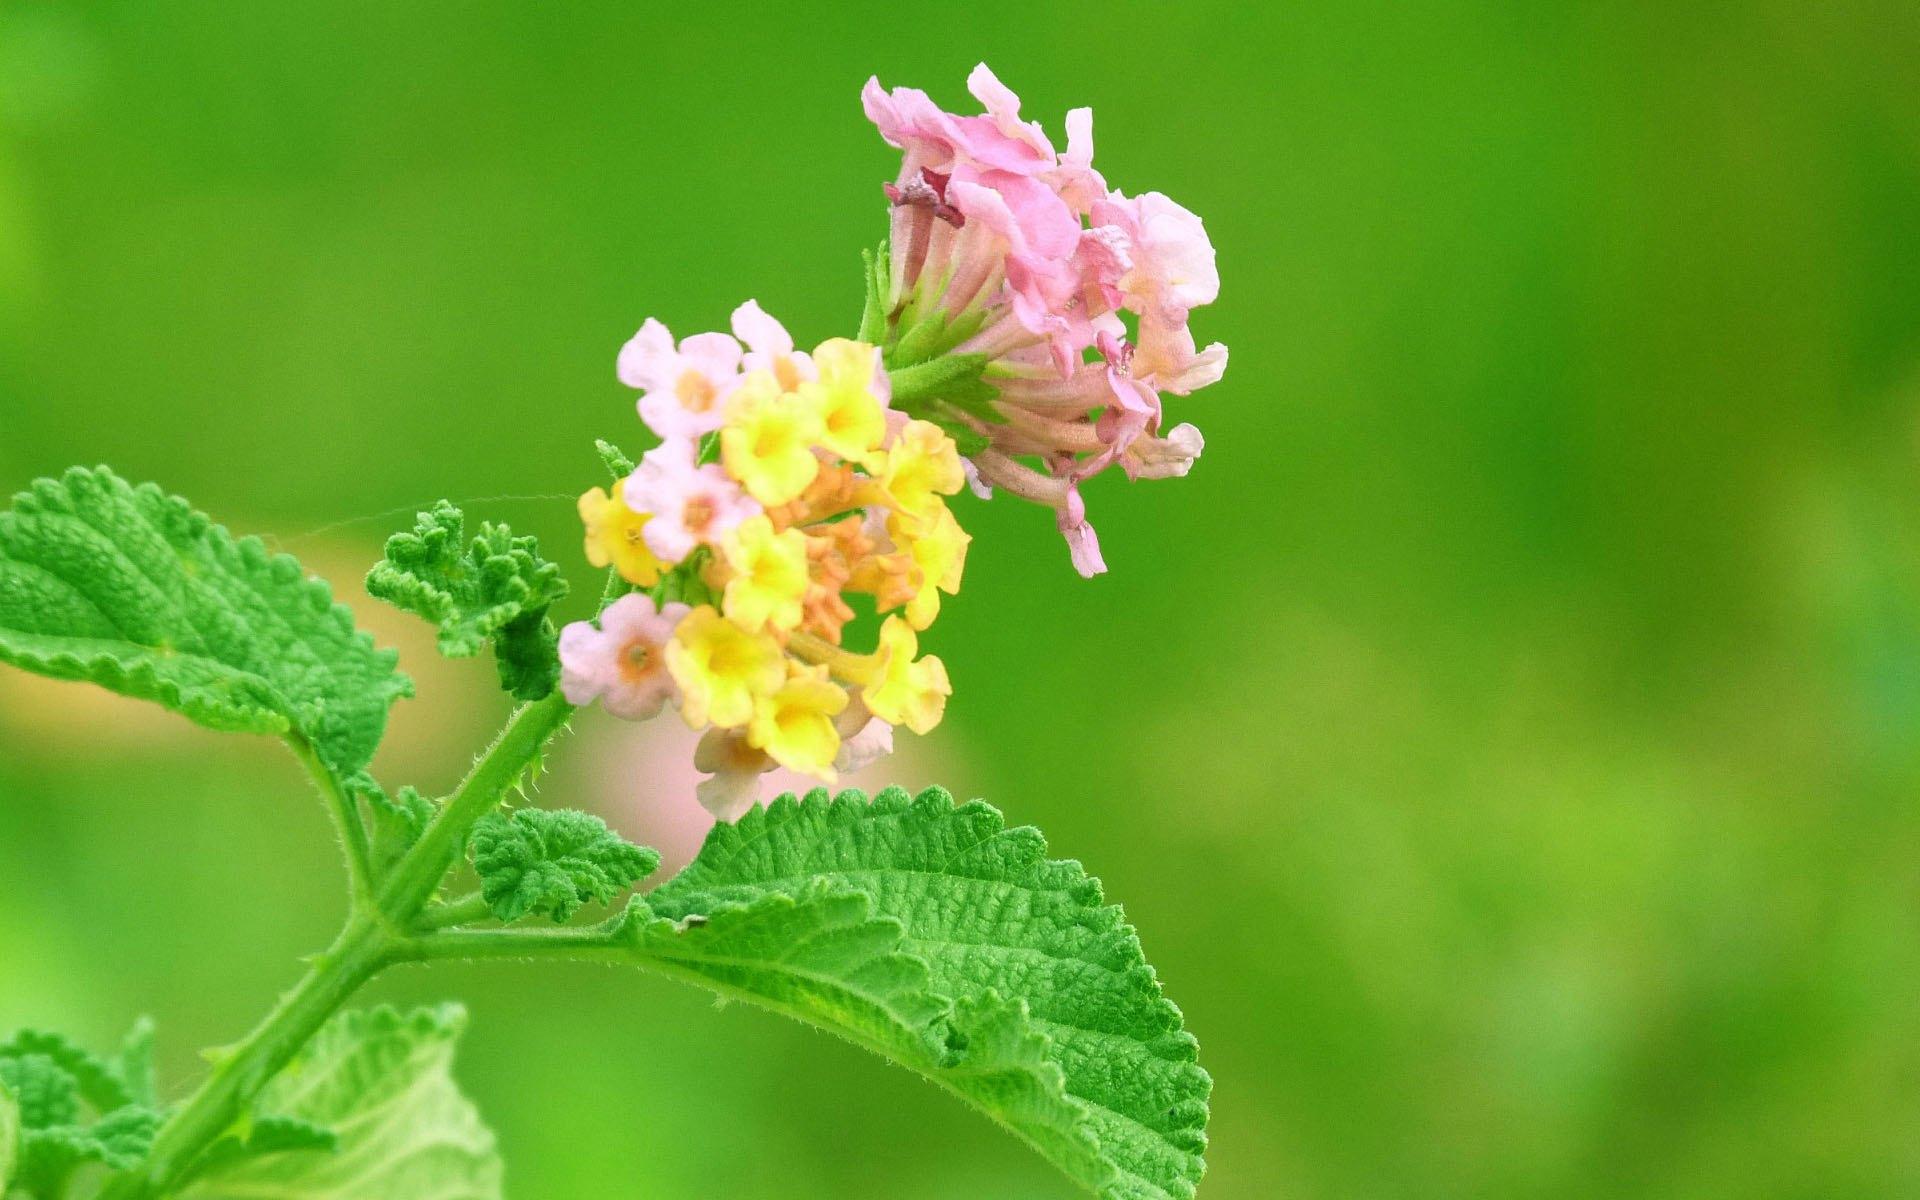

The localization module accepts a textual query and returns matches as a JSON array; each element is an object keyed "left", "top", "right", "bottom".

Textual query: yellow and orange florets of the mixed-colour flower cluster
[{"left": 582, "top": 338, "right": 970, "bottom": 781}]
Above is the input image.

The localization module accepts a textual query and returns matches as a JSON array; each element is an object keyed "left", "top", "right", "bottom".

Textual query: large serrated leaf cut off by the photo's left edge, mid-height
[{"left": 0, "top": 467, "right": 413, "bottom": 776}]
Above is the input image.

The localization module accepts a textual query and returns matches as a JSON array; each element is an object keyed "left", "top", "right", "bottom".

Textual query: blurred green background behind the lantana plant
[{"left": 0, "top": 0, "right": 1920, "bottom": 1200}]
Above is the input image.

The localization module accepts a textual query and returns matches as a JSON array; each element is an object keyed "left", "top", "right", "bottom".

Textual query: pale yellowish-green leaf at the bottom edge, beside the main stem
[{"left": 179, "top": 1006, "right": 501, "bottom": 1200}]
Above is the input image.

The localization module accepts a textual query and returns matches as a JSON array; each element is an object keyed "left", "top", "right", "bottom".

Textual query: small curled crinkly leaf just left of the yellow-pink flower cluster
[{"left": 367, "top": 501, "right": 566, "bottom": 701}]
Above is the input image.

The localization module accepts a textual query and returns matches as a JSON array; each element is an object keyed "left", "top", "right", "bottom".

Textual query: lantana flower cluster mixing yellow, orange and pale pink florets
[{"left": 561, "top": 301, "right": 970, "bottom": 814}]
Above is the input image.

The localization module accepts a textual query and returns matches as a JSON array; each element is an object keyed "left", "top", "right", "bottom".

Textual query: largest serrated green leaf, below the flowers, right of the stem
[{"left": 624, "top": 789, "right": 1212, "bottom": 1200}]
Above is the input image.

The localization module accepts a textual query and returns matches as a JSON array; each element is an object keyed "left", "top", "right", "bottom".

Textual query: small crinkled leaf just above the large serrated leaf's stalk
[{"left": 472, "top": 808, "right": 660, "bottom": 922}]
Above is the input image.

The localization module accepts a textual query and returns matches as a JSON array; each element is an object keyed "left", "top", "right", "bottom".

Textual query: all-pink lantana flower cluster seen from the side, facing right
[{"left": 862, "top": 63, "right": 1227, "bottom": 576}]
